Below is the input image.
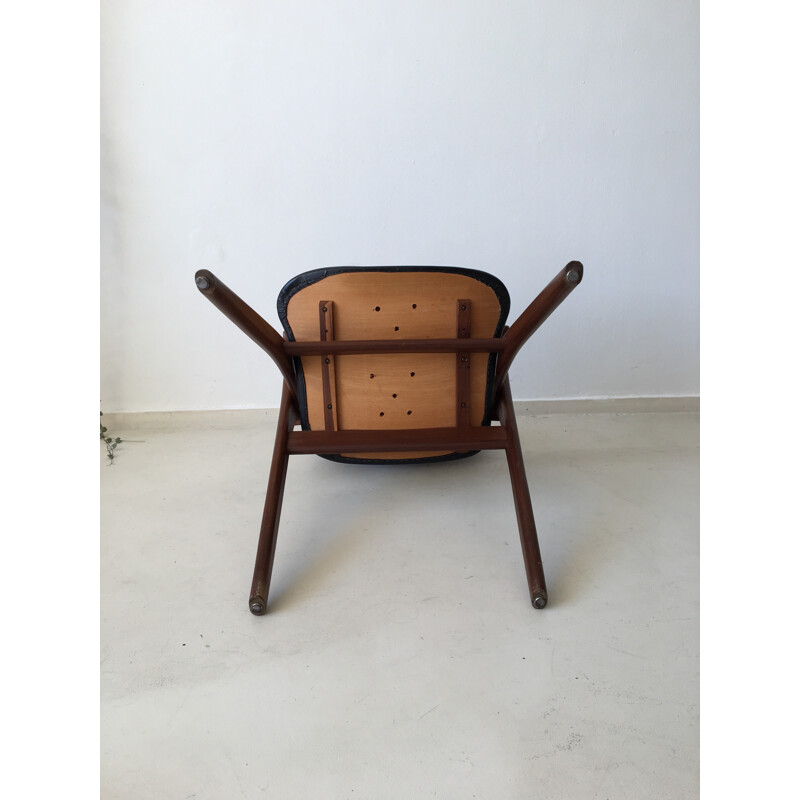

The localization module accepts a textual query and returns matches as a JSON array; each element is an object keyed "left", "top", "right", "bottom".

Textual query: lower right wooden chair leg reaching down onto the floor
[{"left": 497, "top": 378, "right": 547, "bottom": 608}]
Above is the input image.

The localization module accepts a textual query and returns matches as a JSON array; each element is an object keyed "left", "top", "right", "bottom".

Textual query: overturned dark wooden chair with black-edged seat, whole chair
[{"left": 195, "top": 261, "right": 583, "bottom": 615}]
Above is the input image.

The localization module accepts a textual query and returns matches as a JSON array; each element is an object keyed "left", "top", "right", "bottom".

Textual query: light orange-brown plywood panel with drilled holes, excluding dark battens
[{"left": 287, "top": 271, "right": 500, "bottom": 459}]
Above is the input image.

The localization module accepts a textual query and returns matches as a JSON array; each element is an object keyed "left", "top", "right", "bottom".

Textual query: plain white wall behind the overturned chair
[{"left": 101, "top": 0, "right": 699, "bottom": 411}]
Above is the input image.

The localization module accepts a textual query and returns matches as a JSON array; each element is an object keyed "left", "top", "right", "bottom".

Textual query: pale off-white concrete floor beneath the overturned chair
[{"left": 101, "top": 411, "right": 699, "bottom": 800}]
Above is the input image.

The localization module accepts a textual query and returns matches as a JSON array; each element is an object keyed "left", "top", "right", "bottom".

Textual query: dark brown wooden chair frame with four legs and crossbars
[{"left": 195, "top": 261, "right": 583, "bottom": 616}]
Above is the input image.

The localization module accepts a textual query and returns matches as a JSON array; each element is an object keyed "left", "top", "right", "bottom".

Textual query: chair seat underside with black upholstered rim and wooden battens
[{"left": 278, "top": 267, "right": 509, "bottom": 463}]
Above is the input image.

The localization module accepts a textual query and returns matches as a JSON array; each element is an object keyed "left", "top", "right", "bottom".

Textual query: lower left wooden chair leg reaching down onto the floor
[{"left": 250, "top": 383, "right": 298, "bottom": 616}]
